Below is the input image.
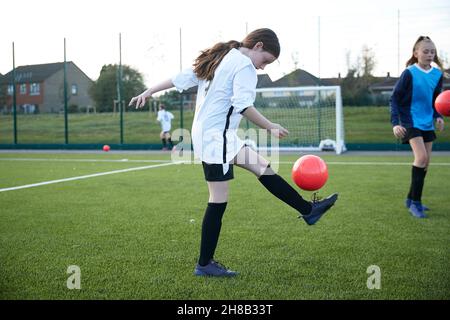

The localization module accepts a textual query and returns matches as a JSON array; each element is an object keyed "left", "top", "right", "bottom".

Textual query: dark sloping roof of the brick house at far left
[{"left": 0, "top": 61, "right": 89, "bottom": 83}]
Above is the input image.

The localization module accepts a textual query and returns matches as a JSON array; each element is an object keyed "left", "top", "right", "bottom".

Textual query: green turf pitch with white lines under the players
[{"left": 0, "top": 153, "right": 450, "bottom": 300}]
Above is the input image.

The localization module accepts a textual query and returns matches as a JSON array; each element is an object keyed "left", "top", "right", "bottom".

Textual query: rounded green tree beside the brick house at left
[{"left": 89, "top": 64, "right": 145, "bottom": 112}]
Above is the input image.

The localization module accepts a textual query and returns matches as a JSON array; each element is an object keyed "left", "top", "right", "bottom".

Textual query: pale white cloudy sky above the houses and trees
[{"left": 0, "top": 0, "right": 450, "bottom": 85}]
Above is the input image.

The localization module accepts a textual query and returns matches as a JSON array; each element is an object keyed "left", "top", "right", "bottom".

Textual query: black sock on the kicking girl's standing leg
[{"left": 198, "top": 202, "right": 227, "bottom": 266}]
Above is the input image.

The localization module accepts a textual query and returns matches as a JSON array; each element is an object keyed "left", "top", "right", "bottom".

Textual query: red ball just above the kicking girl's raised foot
[{"left": 292, "top": 155, "right": 328, "bottom": 191}]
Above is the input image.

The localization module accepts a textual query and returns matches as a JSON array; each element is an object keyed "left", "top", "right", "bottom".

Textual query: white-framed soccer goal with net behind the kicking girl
[{"left": 244, "top": 86, "right": 346, "bottom": 154}]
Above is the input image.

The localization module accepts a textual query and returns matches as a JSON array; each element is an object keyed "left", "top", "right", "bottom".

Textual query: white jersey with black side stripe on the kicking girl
[{"left": 172, "top": 49, "right": 258, "bottom": 164}]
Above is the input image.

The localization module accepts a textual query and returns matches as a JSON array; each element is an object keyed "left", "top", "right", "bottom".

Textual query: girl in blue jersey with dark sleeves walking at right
[{"left": 391, "top": 36, "right": 444, "bottom": 218}]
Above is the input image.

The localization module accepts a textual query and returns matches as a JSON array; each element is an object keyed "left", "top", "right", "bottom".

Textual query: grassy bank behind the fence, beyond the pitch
[{"left": 0, "top": 107, "right": 450, "bottom": 144}]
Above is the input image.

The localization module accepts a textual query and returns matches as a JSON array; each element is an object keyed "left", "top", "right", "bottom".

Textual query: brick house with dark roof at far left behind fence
[{"left": 0, "top": 61, "right": 94, "bottom": 113}]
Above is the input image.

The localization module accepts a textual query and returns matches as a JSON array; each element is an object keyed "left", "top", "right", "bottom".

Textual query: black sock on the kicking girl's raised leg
[{"left": 259, "top": 174, "right": 311, "bottom": 215}]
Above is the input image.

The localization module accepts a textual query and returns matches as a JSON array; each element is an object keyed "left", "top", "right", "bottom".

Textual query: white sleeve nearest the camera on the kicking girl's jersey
[{"left": 231, "top": 65, "right": 258, "bottom": 113}]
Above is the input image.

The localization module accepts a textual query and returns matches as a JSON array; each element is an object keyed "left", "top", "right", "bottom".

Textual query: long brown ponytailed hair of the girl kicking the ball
[{"left": 194, "top": 28, "right": 280, "bottom": 80}]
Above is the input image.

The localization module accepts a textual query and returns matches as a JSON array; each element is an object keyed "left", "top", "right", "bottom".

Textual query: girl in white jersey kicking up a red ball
[{"left": 130, "top": 28, "right": 337, "bottom": 277}]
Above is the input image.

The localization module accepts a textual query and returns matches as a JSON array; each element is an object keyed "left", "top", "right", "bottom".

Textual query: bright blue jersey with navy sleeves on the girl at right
[{"left": 390, "top": 64, "right": 443, "bottom": 131}]
